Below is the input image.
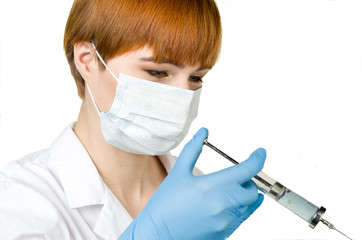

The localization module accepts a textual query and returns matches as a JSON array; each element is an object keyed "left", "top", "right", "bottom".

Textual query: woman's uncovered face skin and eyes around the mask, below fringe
[{"left": 92, "top": 46, "right": 210, "bottom": 112}]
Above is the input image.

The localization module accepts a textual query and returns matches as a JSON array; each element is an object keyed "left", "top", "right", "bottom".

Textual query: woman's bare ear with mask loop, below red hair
[{"left": 74, "top": 42, "right": 98, "bottom": 86}]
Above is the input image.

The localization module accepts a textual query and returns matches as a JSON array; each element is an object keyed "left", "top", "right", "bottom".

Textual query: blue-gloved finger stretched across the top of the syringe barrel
[{"left": 207, "top": 148, "right": 266, "bottom": 184}]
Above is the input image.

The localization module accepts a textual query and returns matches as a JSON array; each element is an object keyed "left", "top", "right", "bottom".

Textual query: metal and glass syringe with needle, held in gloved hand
[{"left": 204, "top": 139, "right": 352, "bottom": 240}]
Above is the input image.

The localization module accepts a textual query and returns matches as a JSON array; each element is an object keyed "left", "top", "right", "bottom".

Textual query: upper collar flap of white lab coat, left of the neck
[{"left": 50, "top": 124, "right": 105, "bottom": 208}]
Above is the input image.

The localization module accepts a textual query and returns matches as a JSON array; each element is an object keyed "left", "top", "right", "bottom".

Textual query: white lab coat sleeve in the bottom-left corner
[{"left": 0, "top": 172, "right": 71, "bottom": 240}]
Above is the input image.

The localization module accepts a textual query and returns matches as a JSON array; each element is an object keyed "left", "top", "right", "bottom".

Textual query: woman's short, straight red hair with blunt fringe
[{"left": 64, "top": 0, "right": 221, "bottom": 98}]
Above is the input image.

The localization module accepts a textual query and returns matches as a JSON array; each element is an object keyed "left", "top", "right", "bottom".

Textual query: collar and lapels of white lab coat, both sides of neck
[{"left": 51, "top": 123, "right": 180, "bottom": 239}]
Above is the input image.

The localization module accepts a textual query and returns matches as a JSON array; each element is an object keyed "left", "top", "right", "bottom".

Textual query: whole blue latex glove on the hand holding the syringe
[{"left": 119, "top": 128, "right": 266, "bottom": 240}]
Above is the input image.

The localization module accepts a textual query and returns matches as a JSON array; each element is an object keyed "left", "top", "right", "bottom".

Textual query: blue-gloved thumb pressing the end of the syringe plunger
[{"left": 173, "top": 128, "right": 209, "bottom": 174}]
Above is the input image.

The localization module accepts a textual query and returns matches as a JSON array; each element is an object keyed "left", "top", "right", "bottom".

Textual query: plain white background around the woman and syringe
[{"left": 0, "top": 0, "right": 362, "bottom": 240}]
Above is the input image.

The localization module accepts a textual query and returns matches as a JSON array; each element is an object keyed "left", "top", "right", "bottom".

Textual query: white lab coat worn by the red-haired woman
[{"left": 0, "top": 125, "right": 202, "bottom": 240}]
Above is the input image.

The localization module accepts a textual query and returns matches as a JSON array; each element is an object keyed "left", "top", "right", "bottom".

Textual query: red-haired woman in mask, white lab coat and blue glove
[{"left": 0, "top": 0, "right": 266, "bottom": 240}]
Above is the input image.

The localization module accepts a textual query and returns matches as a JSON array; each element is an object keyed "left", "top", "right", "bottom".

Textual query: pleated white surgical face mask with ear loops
[{"left": 87, "top": 45, "right": 201, "bottom": 155}]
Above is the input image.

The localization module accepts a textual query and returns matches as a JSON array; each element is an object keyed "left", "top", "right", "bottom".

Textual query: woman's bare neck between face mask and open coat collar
[{"left": 73, "top": 97, "right": 167, "bottom": 217}]
